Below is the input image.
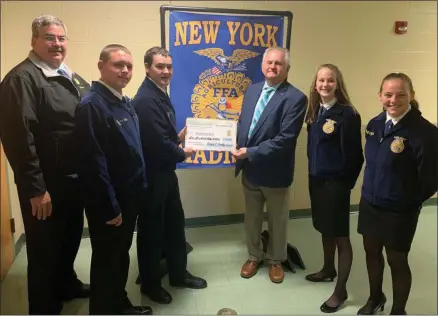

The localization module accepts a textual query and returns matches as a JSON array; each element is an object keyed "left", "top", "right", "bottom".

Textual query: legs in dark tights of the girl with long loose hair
[{"left": 321, "top": 235, "right": 353, "bottom": 306}]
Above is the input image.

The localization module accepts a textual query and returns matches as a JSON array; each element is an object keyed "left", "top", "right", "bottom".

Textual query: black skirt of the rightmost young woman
[{"left": 357, "top": 198, "right": 420, "bottom": 252}]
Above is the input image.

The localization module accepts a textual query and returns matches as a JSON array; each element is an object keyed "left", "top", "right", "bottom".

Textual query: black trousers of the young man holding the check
[{"left": 137, "top": 170, "right": 187, "bottom": 289}]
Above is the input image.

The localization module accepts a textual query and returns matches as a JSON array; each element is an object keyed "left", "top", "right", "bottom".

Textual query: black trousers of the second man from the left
[{"left": 86, "top": 196, "right": 141, "bottom": 315}]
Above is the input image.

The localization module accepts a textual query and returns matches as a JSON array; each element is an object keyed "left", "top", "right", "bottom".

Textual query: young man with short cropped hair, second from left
[{"left": 76, "top": 45, "right": 152, "bottom": 315}]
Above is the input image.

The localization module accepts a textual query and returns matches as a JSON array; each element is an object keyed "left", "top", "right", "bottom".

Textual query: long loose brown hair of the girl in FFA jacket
[{"left": 305, "top": 64, "right": 356, "bottom": 124}]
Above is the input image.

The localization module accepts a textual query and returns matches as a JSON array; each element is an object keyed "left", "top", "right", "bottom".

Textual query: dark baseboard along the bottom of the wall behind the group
[{"left": 14, "top": 198, "right": 438, "bottom": 257}]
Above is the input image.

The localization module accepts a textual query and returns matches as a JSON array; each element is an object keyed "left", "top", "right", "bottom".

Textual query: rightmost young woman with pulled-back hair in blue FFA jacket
[{"left": 358, "top": 73, "right": 438, "bottom": 315}]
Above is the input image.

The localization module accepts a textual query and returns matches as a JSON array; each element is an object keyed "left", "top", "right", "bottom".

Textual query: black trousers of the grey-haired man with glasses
[{"left": 18, "top": 177, "right": 84, "bottom": 314}]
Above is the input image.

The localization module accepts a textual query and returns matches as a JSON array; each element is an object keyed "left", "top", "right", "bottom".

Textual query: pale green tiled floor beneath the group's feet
[{"left": 0, "top": 206, "right": 437, "bottom": 315}]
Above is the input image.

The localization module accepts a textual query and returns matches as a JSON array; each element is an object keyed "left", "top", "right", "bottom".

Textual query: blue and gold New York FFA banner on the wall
[{"left": 169, "top": 11, "right": 284, "bottom": 168}]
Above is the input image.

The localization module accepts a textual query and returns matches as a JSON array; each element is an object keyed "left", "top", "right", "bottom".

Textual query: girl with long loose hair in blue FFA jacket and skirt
[{"left": 306, "top": 64, "right": 364, "bottom": 313}]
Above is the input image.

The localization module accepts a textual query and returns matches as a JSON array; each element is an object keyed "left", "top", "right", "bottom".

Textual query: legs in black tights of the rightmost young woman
[{"left": 363, "top": 236, "right": 412, "bottom": 315}]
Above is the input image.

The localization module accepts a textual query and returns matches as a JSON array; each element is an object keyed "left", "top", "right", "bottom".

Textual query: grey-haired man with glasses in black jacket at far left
[{"left": 0, "top": 15, "right": 90, "bottom": 314}]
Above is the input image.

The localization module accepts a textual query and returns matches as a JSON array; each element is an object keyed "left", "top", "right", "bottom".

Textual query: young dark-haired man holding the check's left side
[{"left": 133, "top": 47, "right": 207, "bottom": 304}]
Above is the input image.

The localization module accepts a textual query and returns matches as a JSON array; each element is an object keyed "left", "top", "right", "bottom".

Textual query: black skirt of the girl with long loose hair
[{"left": 309, "top": 177, "right": 351, "bottom": 237}]
